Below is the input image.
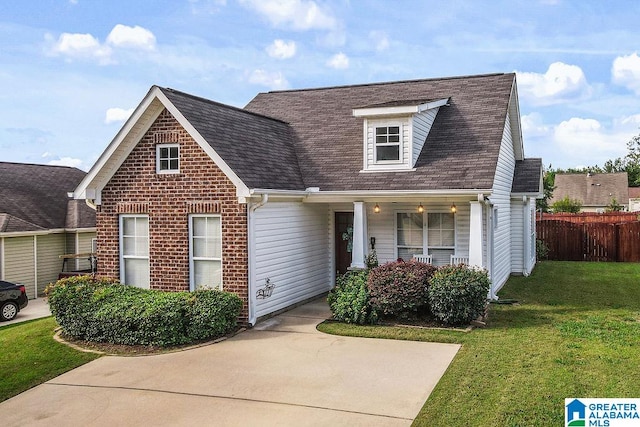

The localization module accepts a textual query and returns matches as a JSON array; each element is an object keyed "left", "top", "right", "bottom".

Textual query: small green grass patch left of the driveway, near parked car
[{"left": 0, "top": 317, "right": 99, "bottom": 402}]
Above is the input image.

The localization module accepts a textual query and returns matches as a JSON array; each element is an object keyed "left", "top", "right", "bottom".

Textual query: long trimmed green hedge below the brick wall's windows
[{"left": 46, "top": 276, "right": 242, "bottom": 347}]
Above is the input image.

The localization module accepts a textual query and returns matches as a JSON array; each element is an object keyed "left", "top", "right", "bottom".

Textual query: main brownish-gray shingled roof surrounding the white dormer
[{"left": 242, "top": 74, "right": 515, "bottom": 191}]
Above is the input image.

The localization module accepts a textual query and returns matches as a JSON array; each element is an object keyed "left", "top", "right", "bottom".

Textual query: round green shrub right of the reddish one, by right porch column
[{"left": 429, "top": 265, "right": 491, "bottom": 325}]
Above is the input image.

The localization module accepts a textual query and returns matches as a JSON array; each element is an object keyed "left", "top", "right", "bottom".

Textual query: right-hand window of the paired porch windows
[{"left": 427, "top": 212, "right": 456, "bottom": 265}]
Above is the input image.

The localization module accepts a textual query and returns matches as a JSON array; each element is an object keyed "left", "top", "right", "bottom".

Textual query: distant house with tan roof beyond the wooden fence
[{"left": 549, "top": 172, "right": 629, "bottom": 213}]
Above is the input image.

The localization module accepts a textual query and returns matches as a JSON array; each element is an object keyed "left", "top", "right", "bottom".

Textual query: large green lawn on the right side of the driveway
[{"left": 319, "top": 261, "right": 640, "bottom": 426}]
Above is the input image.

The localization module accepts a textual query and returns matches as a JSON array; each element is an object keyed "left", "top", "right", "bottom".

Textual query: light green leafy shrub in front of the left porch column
[{"left": 327, "top": 270, "right": 377, "bottom": 325}]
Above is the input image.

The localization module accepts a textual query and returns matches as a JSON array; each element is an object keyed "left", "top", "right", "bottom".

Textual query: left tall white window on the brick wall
[{"left": 120, "top": 215, "right": 149, "bottom": 289}]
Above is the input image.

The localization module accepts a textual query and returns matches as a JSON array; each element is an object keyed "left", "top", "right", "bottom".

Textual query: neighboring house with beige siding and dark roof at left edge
[{"left": 0, "top": 162, "right": 96, "bottom": 298}]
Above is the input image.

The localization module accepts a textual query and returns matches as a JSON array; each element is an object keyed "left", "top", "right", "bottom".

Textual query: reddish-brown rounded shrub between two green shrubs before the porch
[{"left": 367, "top": 260, "right": 436, "bottom": 316}]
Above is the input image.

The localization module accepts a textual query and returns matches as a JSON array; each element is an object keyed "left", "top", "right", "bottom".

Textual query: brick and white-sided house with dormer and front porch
[{"left": 75, "top": 74, "right": 542, "bottom": 324}]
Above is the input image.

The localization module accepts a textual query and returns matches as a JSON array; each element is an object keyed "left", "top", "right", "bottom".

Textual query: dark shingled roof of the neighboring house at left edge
[{"left": 0, "top": 162, "right": 96, "bottom": 232}]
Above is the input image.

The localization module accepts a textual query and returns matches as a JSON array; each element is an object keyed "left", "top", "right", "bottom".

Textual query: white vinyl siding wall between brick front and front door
[{"left": 251, "top": 202, "right": 333, "bottom": 317}]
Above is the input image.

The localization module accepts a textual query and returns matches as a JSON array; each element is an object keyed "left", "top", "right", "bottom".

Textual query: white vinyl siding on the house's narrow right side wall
[{"left": 491, "top": 110, "right": 522, "bottom": 292}]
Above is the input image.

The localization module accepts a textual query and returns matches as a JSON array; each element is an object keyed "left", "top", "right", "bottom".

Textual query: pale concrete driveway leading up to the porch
[{"left": 0, "top": 300, "right": 459, "bottom": 426}]
